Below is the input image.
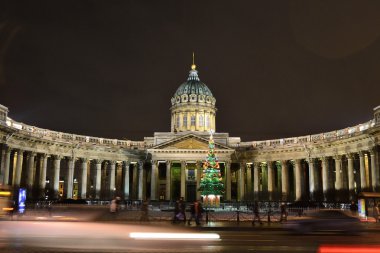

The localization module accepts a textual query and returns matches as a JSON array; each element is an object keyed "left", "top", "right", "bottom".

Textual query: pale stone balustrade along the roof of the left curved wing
[{"left": 6, "top": 118, "right": 146, "bottom": 150}]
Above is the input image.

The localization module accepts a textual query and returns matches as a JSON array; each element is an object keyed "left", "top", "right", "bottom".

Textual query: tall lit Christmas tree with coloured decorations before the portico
[{"left": 198, "top": 132, "right": 224, "bottom": 207}]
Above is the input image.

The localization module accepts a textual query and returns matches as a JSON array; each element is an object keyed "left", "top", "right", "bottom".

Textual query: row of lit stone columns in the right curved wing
[{"left": 238, "top": 148, "right": 380, "bottom": 201}]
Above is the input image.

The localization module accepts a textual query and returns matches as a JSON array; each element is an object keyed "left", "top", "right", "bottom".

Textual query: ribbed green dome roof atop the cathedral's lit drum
[{"left": 174, "top": 70, "right": 213, "bottom": 97}]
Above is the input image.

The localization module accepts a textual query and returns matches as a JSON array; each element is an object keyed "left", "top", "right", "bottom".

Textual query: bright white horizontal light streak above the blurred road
[{"left": 129, "top": 232, "right": 220, "bottom": 240}]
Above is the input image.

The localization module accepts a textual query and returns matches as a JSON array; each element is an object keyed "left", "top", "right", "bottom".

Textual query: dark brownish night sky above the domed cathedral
[{"left": 0, "top": 0, "right": 380, "bottom": 141}]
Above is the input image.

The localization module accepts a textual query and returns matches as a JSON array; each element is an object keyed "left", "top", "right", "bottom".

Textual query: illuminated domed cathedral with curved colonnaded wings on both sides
[{"left": 0, "top": 64, "right": 380, "bottom": 205}]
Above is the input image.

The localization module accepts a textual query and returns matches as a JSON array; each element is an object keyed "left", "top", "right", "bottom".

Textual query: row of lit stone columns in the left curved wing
[{"left": 0, "top": 145, "right": 144, "bottom": 199}]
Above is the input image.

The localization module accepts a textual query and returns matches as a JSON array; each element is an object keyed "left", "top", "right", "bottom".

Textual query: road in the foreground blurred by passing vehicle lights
[{"left": 0, "top": 221, "right": 380, "bottom": 253}]
